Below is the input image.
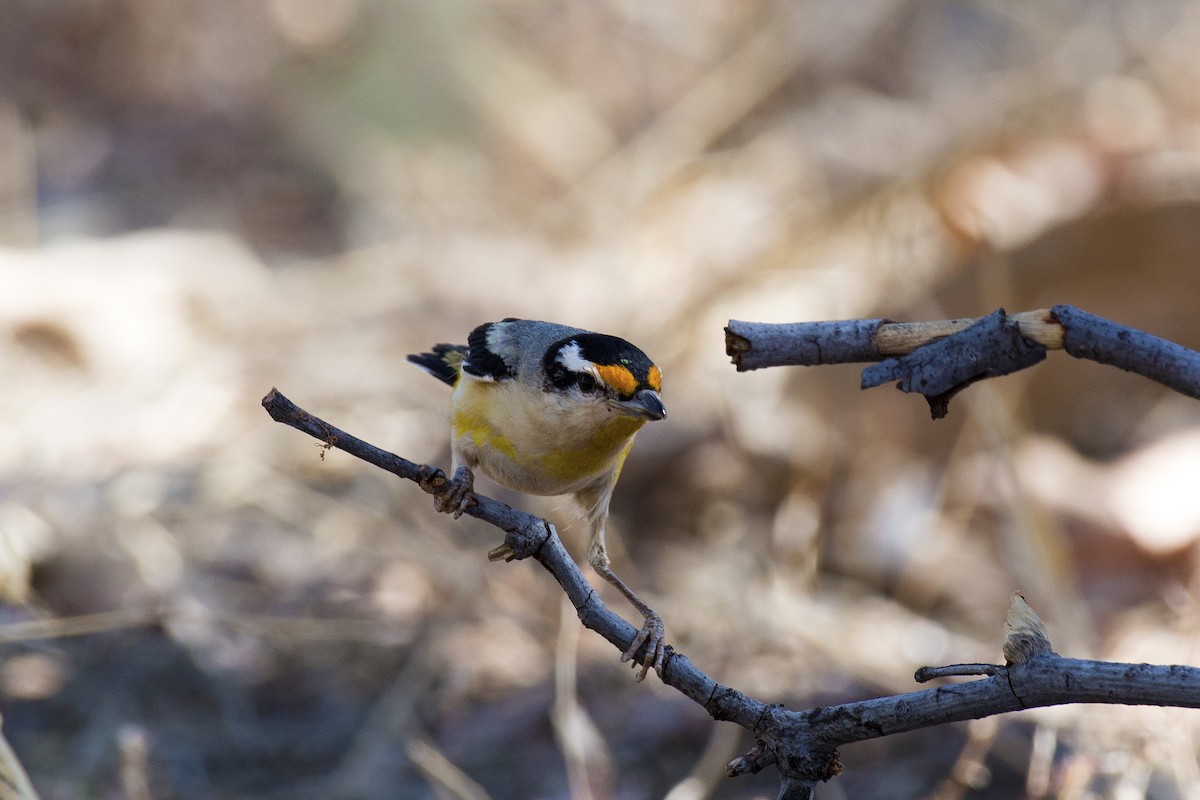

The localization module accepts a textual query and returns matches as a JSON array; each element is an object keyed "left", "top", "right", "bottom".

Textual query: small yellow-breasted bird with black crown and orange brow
[{"left": 408, "top": 317, "right": 667, "bottom": 680}]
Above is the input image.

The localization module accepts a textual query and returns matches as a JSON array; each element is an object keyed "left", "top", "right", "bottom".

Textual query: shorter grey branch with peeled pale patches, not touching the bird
[{"left": 725, "top": 305, "right": 1200, "bottom": 419}]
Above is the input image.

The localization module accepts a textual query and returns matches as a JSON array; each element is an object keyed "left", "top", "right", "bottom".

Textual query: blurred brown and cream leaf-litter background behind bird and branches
[{"left": 0, "top": 0, "right": 1200, "bottom": 800}]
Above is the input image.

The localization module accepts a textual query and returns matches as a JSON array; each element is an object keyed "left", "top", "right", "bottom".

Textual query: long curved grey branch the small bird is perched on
[{"left": 263, "top": 390, "right": 1200, "bottom": 799}]
